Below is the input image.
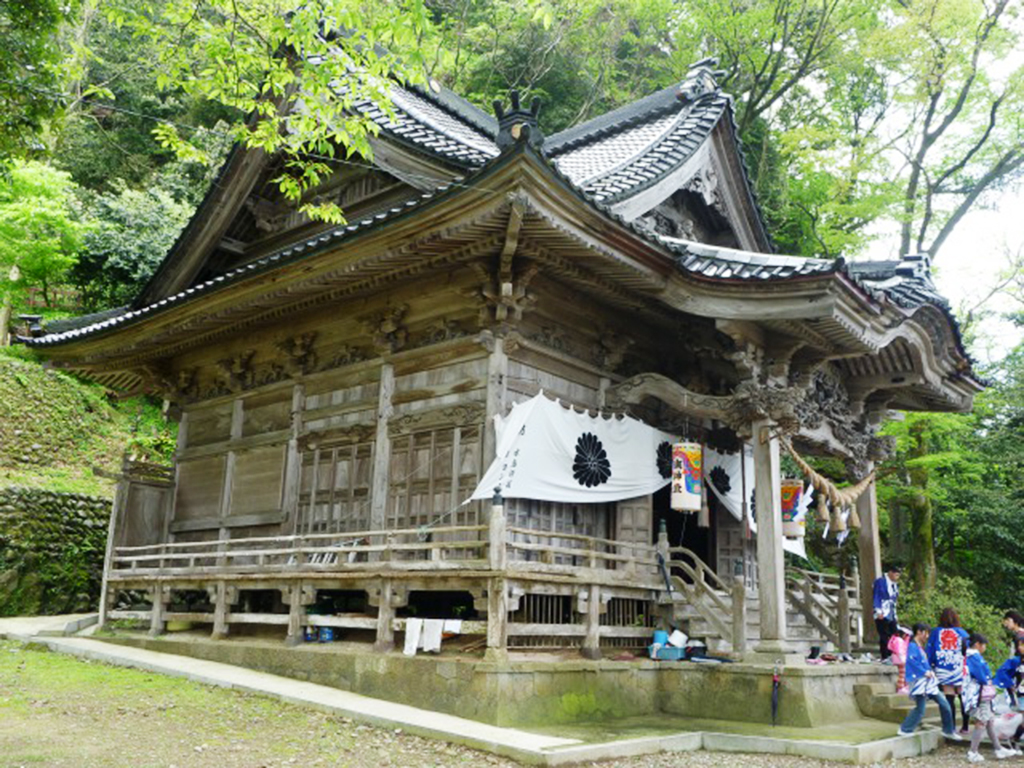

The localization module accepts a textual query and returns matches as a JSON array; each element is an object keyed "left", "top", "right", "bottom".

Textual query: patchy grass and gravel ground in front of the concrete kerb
[{"left": 0, "top": 643, "right": 987, "bottom": 768}]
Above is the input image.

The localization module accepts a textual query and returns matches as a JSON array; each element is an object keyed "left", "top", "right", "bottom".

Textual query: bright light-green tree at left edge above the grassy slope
[{"left": 0, "top": 161, "right": 84, "bottom": 344}]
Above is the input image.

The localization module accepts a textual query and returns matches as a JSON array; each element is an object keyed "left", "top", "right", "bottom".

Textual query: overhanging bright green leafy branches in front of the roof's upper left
[{"left": 104, "top": 0, "right": 432, "bottom": 221}]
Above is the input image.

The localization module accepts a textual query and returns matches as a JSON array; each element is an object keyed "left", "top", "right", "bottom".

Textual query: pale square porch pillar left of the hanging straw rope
[{"left": 753, "top": 420, "right": 790, "bottom": 653}]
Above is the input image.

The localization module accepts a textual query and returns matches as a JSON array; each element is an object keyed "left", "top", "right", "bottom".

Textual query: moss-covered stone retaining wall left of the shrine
[{"left": 0, "top": 487, "right": 111, "bottom": 615}]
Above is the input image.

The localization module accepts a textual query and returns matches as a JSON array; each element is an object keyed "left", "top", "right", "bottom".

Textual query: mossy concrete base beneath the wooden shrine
[{"left": 96, "top": 633, "right": 891, "bottom": 728}]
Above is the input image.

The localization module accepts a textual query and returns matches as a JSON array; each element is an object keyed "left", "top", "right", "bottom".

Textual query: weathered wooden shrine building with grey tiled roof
[{"left": 26, "top": 61, "right": 981, "bottom": 657}]
